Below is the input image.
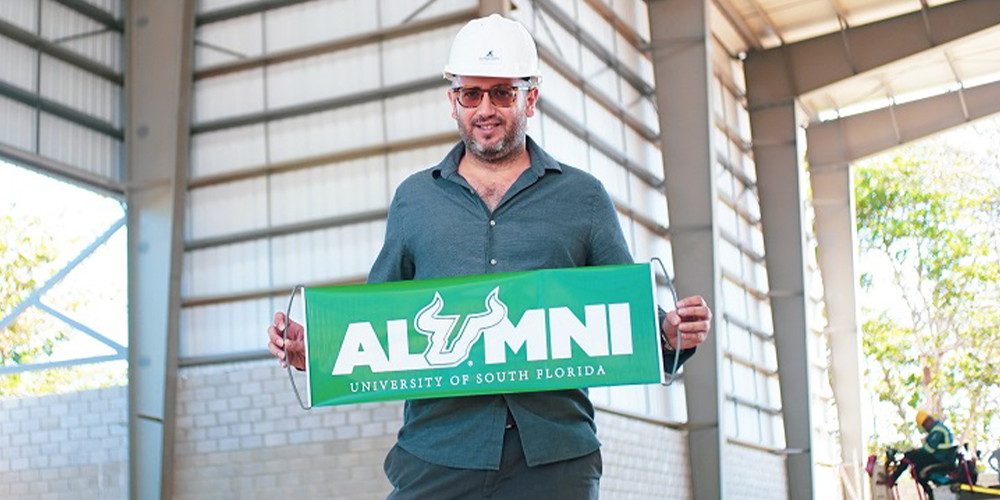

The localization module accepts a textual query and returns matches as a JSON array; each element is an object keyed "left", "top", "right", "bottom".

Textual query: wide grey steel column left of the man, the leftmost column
[{"left": 125, "top": 0, "right": 194, "bottom": 500}]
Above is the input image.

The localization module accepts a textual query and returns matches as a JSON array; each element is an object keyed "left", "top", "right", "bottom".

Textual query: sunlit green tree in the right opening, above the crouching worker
[{"left": 855, "top": 131, "right": 1000, "bottom": 456}]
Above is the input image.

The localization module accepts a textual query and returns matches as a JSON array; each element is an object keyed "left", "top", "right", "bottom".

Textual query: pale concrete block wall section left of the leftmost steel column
[{"left": 0, "top": 387, "right": 128, "bottom": 500}]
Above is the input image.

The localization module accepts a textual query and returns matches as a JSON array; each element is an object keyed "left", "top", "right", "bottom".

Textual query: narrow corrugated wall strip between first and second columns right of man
[{"left": 711, "top": 1, "right": 785, "bottom": 449}]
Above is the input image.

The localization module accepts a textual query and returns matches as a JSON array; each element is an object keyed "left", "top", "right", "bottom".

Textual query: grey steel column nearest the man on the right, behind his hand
[{"left": 649, "top": 0, "right": 735, "bottom": 499}]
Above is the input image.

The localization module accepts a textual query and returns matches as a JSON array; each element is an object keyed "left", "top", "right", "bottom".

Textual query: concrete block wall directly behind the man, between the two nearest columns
[{"left": 174, "top": 361, "right": 690, "bottom": 500}]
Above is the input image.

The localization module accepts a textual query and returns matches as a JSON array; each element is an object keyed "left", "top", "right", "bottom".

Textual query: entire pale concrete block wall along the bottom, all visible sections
[{"left": 0, "top": 361, "right": 787, "bottom": 500}]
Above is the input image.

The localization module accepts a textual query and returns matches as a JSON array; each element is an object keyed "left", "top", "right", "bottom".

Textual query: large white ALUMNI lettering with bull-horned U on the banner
[{"left": 333, "top": 287, "right": 632, "bottom": 375}]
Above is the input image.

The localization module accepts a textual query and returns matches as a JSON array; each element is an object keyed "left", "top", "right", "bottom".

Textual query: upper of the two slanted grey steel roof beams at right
[{"left": 746, "top": 0, "right": 1000, "bottom": 107}]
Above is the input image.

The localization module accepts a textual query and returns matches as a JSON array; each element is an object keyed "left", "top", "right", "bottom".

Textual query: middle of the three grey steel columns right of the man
[{"left": 748, "top": 99, "right": 814, "bottom": 500}]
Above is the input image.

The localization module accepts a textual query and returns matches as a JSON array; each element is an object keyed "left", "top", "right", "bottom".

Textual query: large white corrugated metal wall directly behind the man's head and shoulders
[{"left": 180, "top": 0, "right": 684, "bottom": 420}]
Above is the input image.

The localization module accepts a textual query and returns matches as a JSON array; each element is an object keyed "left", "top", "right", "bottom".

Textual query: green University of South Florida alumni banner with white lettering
[{"left": 303, "top": 264, "right": 663, "bottom": 406}]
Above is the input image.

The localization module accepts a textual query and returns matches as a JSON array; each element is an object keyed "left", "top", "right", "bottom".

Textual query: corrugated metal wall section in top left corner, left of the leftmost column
[{"left": 0, "top": 0, "right": 124, "bottom": 181}]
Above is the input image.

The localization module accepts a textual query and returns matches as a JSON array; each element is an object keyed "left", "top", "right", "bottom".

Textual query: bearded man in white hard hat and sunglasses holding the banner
[{"left": 269, "top": 15, "right": 711, "bottom": 500}]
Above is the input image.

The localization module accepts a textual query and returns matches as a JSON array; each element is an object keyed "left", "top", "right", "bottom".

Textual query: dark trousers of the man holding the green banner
[{"left": 384, "top": 427, "right": 603, "bottom": 500}]
